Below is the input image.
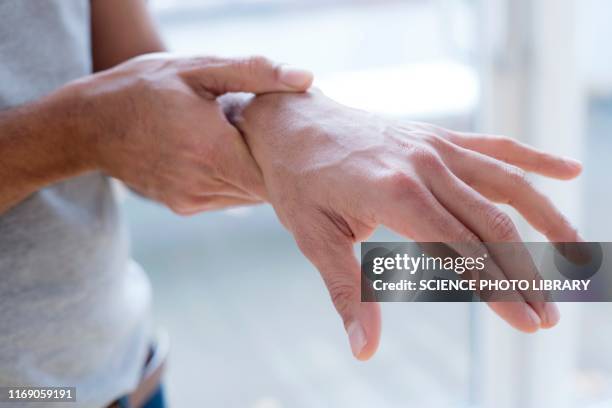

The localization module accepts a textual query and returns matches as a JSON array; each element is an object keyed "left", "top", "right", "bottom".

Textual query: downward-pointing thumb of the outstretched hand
[{"left": 296, "top": 230, "right": 381, "bottom": 361}]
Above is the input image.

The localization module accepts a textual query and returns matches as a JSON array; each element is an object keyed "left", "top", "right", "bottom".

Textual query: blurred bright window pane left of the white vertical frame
[{"left": 126, "top": 0, "right": 478, "bottom": 407}]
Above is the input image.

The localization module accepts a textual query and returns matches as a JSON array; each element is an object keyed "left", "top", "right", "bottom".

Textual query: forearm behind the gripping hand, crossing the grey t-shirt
[{"left": 0, "top": 91, "right": 90, "bottom": 214}]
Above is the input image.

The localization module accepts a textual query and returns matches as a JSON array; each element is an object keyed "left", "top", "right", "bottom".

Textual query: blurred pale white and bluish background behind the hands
[{"left": 124, "top": 0, "right": 612, "bottom": 408}]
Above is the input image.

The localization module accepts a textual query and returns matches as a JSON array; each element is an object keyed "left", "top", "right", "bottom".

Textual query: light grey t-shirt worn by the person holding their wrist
[{"left": 0, "top": 0, "right": 151, "bottom": 408}]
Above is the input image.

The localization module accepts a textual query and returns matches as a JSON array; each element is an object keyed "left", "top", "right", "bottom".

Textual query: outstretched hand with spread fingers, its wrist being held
[{"left": 230, "top": 92, "right": 581, "bottom": 359}]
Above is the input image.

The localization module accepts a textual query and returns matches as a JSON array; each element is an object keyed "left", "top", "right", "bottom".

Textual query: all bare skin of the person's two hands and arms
[{"left": 0, "top": 0, "right": 580, "bottom": 359}]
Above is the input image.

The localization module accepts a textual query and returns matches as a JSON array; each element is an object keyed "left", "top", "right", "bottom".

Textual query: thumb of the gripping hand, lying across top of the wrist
[{"left": 182, "top": 56, "right": 313, "bottom": 96}]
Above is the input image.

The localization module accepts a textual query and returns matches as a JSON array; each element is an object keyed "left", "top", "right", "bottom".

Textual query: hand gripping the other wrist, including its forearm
[{"left": 0, "top": 54, "right": 312, "bottom": 214}]
